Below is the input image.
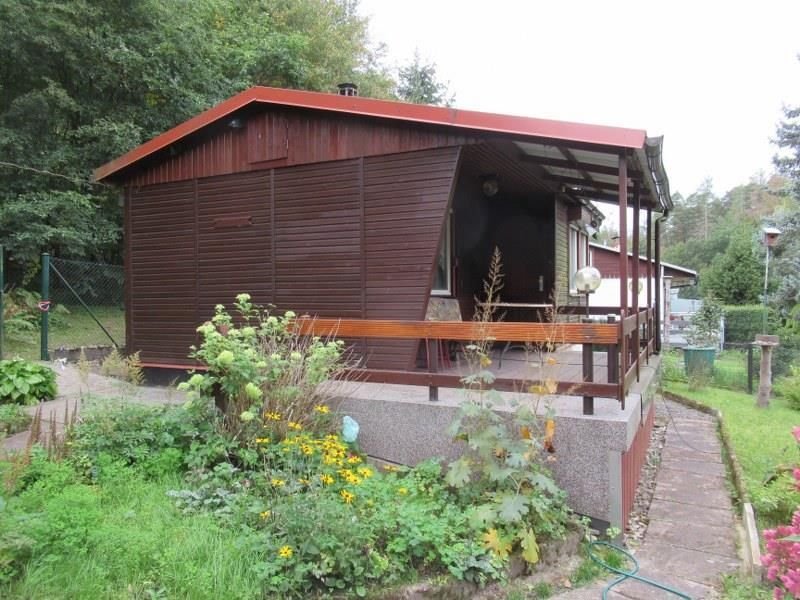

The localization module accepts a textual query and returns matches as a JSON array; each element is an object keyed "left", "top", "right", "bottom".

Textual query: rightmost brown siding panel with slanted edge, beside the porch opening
[{"left": 364, "top": 148, "right": 459, "bottom": 369}]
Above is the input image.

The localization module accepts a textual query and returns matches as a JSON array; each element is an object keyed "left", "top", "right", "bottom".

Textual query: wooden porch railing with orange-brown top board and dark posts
[{"left": 297, "top": 307, "right": 654, "bottom": 414}]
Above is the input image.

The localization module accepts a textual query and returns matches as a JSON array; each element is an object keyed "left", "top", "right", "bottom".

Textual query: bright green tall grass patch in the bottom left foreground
[{"left": 0, "top": 473, "right": 268, "bottom": 600}]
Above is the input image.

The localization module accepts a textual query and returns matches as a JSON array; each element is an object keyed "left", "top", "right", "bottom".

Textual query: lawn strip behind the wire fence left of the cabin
[{"left": 4, "top": 306, "right": 125, "bottom": 360}]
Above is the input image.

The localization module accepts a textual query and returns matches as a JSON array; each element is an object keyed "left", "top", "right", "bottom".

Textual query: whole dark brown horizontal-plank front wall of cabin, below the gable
[{"left": 127, "top": 147, "right": 459, "bottom": 369}]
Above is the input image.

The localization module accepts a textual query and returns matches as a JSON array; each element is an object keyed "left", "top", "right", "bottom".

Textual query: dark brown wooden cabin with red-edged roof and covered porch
[{"left": 95, "top": 87, "right": 670, "bottom": 404}]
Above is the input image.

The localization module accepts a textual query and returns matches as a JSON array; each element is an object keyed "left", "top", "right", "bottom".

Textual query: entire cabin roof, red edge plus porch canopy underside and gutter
[{"left": 94, "top": 87, "right": 671, "bottom": 210}]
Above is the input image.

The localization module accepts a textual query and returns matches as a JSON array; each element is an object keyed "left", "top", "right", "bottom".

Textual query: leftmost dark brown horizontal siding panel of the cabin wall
[{"left": 127, "top": 181, "right": 198, "bottom": 363}]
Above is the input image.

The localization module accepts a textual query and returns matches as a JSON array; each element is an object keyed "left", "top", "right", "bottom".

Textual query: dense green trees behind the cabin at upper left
[{"left": 0, "top": 0, "right": 393, "bottom": 276}]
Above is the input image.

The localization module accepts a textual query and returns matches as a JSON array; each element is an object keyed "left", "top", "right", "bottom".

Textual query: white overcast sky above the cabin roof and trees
[{"left": 361, "top": 0, "right": 800, "bottom": 196}]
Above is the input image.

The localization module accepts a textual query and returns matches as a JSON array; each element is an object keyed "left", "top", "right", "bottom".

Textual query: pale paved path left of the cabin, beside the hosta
[{"left": 3, "top": 363, "right": 185, "bottom": 451}]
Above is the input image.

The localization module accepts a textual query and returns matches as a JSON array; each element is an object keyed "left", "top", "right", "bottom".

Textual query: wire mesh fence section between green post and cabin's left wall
[{"left": 48, "top": 258, "right": 125, "bottom": 349}]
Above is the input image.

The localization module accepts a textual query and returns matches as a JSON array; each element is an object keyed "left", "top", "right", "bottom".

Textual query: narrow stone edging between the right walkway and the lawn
[{"left": 663, "top": 390, "right": 763, "bottom": 580}]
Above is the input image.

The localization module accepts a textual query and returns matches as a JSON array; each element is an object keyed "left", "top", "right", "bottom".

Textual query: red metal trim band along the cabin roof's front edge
[{"left": 94, "top": 87, "right": 647, "bottom": 181}]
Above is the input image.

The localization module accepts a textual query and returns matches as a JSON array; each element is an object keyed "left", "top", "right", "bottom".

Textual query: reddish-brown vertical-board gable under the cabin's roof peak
[{"left": 126, "top": 107, "right": 477, "bottom": 186}]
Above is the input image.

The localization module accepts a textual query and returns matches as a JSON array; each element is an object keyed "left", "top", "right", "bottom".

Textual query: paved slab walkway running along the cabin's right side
[{"left": 556, "top": 400, "right": 741, "bottom": 600}]
